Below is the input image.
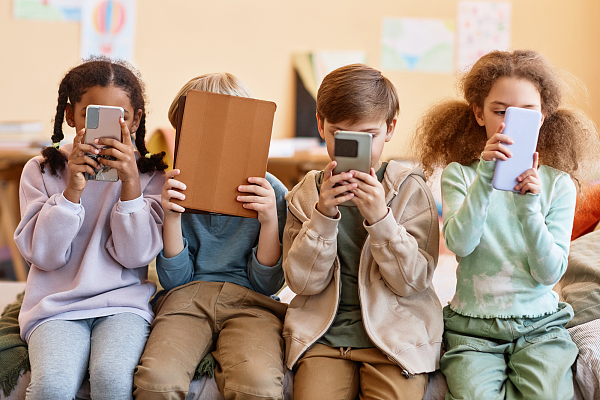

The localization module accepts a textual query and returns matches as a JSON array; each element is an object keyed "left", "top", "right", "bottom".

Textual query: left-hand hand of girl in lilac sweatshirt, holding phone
[{"left": 64, "top": 128, "right": 100, "bottom": 203}]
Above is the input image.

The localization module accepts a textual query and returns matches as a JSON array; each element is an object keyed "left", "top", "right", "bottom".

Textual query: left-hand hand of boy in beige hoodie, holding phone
[{"left": 317, "top": 161, "right": 357, "bottom": 218}]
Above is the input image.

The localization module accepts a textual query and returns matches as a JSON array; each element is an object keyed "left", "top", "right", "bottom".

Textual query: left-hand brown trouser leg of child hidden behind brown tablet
[{"left": 133, "top": 281, "right": 217, "bottom": 399}]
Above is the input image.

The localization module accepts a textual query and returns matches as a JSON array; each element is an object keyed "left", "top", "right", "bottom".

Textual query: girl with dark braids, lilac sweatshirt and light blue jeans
[{"left": 15, "top": 58, "right": 166, "bottom": 399}]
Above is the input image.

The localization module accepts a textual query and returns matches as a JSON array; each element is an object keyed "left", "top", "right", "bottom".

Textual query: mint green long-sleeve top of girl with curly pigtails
[{"left": 442, "top": 161, "right": 576, "bottom": 318}]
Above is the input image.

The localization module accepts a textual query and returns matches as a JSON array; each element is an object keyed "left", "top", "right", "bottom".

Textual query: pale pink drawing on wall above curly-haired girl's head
[{"left": 457, "top": 1, "right": 511, "bottom": 71}]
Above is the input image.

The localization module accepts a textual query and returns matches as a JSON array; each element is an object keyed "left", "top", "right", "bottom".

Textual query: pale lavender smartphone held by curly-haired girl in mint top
[{"left": 492, "top": 107, "right": 542, "bottom": 192}]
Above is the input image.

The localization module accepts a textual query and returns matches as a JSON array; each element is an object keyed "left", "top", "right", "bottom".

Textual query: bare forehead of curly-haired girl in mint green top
[{"left": 485, "top": 77, "right": 541, "bottom": 106}]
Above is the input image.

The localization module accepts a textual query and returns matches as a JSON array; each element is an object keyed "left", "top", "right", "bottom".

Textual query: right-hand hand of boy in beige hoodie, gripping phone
[{"left": 349, "top": 168, "right": 387, "bottom": 225}]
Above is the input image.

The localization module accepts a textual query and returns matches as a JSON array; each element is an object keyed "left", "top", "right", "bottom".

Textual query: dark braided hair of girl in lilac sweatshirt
[{"left": 40, "top": 57, "right": 167, "bottom": 175}]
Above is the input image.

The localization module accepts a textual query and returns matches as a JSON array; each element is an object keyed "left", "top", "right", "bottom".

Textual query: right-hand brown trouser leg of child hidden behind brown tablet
[{"left": 213, "top": 283, "right": 287, "bottom": 400}]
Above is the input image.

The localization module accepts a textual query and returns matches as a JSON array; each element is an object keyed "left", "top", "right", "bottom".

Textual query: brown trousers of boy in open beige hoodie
[{"left": 294, "top": 343, "right": 428, "bottom": 400}]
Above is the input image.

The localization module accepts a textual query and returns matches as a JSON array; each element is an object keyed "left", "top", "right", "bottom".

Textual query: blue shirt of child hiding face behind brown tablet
[{"left": 156, "top": 173, "right": 287, "bottom": 296}]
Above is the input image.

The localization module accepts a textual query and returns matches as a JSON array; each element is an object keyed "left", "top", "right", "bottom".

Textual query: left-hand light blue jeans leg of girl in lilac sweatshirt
[{"left": 27, "top": 320, "right": 90, "bottom": 400}]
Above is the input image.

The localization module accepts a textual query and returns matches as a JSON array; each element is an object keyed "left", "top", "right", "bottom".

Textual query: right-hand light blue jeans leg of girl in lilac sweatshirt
[{"left": 90, "top": 313, "right": 150, "bottom": 400}]
